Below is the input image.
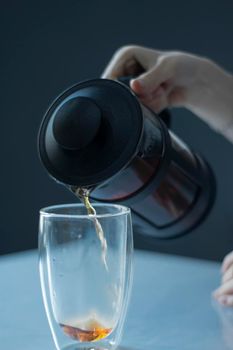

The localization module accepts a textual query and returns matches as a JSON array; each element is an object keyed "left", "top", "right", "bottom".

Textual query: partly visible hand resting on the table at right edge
[{"left": 213, "top": 251, "right": 233, "bottom": 306}]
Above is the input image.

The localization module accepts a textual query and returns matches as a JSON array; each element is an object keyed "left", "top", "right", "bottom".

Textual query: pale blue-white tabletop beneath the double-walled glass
[{"left": 0, "top": 251, "right": 233, "bottom": 350}]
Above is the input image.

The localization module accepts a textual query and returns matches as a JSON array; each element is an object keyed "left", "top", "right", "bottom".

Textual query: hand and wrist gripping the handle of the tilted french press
[{"left": 102, "top": 46, "right": 233, "bottom": 141}]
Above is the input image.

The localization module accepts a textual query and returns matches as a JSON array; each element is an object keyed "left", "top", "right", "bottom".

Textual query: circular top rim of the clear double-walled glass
[{"left": 39, "top": 203, "right": 131, "bottom": 219}]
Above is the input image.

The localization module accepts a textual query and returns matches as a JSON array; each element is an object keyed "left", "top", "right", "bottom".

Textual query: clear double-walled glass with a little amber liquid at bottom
[{"left": 39, "top": 204, "right": 133, "bottom": 350}]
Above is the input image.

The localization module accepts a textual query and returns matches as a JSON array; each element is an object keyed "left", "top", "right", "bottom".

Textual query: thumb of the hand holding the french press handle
[{"left": 130, "top": 62, "right": 171, "bottom": 95}]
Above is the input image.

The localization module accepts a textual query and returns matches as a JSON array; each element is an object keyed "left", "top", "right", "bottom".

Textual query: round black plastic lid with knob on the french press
[{"left": 38, "top": 79, "right": 143, "bottom": 187}]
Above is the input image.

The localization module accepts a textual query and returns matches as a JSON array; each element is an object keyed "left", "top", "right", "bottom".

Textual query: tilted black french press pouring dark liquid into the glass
[{"left": 38, "top": 79, "right": 215, "bottom": 238}]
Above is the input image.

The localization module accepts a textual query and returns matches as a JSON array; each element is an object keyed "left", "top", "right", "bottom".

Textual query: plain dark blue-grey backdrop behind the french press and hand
[{"left": 0, "top": 0, "right": 233, "bottom": 259}]
